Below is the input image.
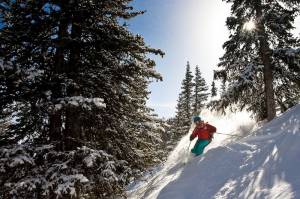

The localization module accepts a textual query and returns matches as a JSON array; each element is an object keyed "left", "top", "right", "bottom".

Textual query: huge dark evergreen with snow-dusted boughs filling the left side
[{"left": 0, "top": 0, "right": 163, "bottom": 198}]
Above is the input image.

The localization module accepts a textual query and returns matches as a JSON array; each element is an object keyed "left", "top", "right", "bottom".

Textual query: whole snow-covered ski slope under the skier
[{"left": 128, "top": 105, "right": 300, "bottom": 199}]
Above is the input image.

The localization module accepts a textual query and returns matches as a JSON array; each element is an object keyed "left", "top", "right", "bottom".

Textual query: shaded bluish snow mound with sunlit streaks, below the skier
[{"left": 157, "top": 104, "right": 300, "bottom": 199}]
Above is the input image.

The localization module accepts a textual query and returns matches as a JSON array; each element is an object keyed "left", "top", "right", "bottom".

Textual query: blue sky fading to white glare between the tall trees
[{"left": 128, "top": 0, "right": 230, "bottom": 117}]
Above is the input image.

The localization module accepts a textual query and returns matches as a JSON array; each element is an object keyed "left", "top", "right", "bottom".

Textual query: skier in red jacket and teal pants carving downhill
[{"left": 190, "top": 116, "right": 217, "bottom": 156}]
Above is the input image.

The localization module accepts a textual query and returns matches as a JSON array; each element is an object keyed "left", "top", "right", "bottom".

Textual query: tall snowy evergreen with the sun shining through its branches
[{"left": 213, "top": 0, "right": 300, "bottom": 120}]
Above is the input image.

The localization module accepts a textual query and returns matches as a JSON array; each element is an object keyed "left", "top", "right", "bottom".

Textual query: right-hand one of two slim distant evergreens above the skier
[{"left": 192, "top": 66, "right": 209, "bottom": 115}]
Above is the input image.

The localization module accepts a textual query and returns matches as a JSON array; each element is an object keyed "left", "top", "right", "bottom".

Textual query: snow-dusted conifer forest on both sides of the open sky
[{"left": 0, "top": 0, "right": 300, "bottom": 199}]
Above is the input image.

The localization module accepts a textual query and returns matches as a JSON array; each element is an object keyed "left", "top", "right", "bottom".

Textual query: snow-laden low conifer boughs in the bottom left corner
[{"left": 0, "top": 144, "right": 132, "bottom": 198}]
